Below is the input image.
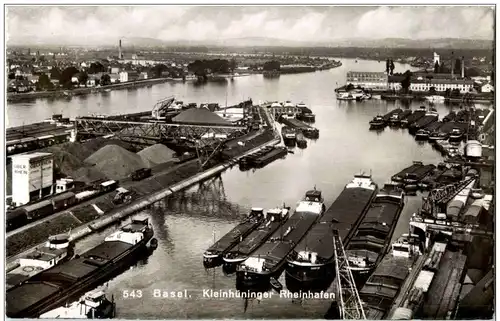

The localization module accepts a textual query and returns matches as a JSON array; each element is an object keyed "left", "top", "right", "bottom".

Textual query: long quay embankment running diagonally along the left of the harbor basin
[{"left": 6, "top": 107, "right": 281, "bottom": 271}]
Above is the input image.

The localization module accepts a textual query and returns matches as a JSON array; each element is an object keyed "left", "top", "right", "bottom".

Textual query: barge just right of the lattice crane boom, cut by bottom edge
[{"left": 359, "top": 234, "right": 422, "bottom": 320}]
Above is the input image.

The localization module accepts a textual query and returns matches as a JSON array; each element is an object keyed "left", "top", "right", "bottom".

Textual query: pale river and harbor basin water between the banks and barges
[{"left": 7, "top": 59, "right": 492, "bottom": 319}]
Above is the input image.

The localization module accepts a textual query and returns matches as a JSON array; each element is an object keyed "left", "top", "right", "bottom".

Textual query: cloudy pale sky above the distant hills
[{"left": 6, "top": 6, "right": 494, "bottom": 45}]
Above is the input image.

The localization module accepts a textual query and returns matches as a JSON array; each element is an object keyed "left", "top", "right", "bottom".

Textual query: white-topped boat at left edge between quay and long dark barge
[{"left": 6, "top": 234, "right": 74, "bottom": 289}]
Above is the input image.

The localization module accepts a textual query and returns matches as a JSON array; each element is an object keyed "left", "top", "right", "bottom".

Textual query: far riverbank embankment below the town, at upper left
[{"left": 7, "top": 78, "right": 175, "bottom": 102}]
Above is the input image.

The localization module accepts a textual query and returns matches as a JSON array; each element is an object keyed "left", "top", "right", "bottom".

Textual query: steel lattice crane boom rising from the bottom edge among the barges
[{"left": 333, "top": 230, "right": 366, "bottom": 320}]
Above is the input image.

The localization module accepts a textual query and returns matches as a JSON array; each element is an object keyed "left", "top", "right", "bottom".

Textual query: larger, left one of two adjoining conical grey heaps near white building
[{"left": 85, "top": 145, "right": 146, "bottom": 180}]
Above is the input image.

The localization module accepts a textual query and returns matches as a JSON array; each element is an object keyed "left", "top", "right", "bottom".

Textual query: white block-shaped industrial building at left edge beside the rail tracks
[{"left": 11, "top": 152, "right": 54, "bottom": 206}]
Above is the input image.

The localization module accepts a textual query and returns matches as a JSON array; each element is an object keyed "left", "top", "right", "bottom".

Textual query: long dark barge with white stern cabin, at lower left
[{"left": 6, "top": 219, "right": 155, "bottom": 318}]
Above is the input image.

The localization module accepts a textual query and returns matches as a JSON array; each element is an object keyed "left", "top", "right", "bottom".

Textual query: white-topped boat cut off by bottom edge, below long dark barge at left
[{"left": 40, "top": 291, "right": 116, "bottom": 319}]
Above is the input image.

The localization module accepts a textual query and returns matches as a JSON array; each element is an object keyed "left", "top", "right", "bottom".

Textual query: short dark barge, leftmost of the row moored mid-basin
[{"left": 203, "top": 208, "right": 264, "bottom": 268}]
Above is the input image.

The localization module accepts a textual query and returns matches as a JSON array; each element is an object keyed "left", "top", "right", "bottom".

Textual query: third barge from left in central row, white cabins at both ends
[{"left": 236, "top": 190, "right": 325, "bottom": 292}]
